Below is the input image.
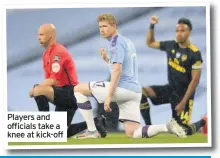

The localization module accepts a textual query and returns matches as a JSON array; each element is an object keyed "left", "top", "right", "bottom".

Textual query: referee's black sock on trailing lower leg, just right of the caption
[{"left": 67, "top": 122, "right": 87, "bottom": 138}]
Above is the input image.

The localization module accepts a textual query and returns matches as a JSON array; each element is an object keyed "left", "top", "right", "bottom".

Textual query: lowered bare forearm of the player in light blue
[{"left": 104, "top": 63, "right": 122, "bottom": 112}]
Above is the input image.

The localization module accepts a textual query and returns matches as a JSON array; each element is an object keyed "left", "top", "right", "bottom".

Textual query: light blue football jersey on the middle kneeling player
[{"left": 107, "top": 34, "right": 141, "bottom": 93}]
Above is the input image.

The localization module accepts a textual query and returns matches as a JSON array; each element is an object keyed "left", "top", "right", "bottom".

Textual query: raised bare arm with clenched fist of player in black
[{"left": 146, "top": 16, "right": 160, "bottom": 48}]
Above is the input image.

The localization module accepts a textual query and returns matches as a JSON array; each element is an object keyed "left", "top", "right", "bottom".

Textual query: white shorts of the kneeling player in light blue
[{"left": 89, "top": 81, "right": 141, "bottom": 123}]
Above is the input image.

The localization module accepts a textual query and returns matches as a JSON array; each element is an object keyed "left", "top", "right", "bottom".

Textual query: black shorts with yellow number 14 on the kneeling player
[{"left": 150, "top": 84, "right": 194, "bottom": 124}]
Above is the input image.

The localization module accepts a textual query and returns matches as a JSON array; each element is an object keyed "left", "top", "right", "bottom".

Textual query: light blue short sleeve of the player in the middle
[{"left": 111, "top": 44, "right": 125, "bottom": 64}]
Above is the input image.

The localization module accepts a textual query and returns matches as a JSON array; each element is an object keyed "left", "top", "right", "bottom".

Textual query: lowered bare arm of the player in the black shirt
[{"left": 176, "top": 69, "right": 202, "bottom": 115}]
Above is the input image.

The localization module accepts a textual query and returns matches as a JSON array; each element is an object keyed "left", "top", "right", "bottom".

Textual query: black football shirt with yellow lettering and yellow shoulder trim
[{"left": 160, "top": 40, "right": 203, "bottom": 96}]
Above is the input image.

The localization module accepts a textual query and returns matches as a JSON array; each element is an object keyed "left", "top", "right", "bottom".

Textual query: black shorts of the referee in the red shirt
[{"left": 52, "top": 86, "right": 78, "bottom": 111}]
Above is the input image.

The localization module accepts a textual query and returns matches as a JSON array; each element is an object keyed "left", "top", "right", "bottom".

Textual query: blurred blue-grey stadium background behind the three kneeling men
[{"left": 7, "top": 7, "right": 208, "bottom": 129}]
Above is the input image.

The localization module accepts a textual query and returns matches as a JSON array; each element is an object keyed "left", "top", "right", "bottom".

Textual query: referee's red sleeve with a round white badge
[{"left": 50, "top": 55, "right": 64, "bottom": 80}]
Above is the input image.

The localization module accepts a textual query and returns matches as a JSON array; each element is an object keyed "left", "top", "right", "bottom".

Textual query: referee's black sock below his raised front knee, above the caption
[{"left": 34, "top": 95, "right": 50, "bottom": 111}]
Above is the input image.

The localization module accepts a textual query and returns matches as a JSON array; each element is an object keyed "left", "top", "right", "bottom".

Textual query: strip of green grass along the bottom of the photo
[{"left": 8, "top": 133, "right": 208, "bottom": 146}]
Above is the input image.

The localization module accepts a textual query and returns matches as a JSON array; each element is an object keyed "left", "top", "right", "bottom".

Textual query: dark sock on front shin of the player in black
[{"left": 140, "top": 94, "right": 151, "bottom": 125}]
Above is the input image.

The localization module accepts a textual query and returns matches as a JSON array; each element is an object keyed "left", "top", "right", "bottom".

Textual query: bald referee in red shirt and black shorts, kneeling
[{"left": 29, "top": 24, "right": 106, "bottom": 136}]
